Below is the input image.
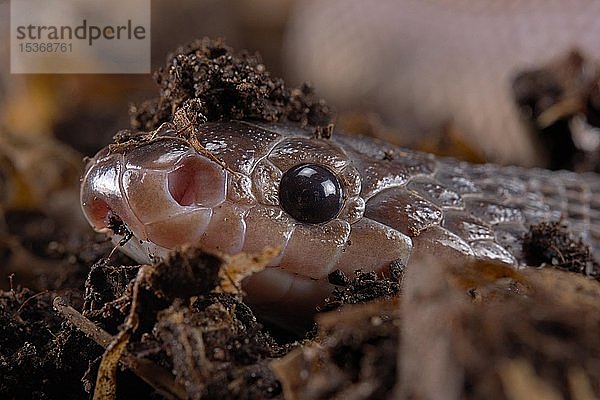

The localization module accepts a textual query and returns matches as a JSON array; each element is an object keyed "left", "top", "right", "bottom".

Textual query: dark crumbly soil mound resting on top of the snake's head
[{"left": 130, "top": 38, "right": 332, "bottom": 131}]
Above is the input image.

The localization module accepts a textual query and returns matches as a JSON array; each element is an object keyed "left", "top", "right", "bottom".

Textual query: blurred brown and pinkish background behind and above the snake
[{"left": 0, "top": 0, "right": 600, "bottom": 288}]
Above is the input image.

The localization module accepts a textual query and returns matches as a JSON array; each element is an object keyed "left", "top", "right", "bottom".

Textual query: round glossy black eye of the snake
[{"left": 279, "top": 164, "right": 342, "bottom": 224}]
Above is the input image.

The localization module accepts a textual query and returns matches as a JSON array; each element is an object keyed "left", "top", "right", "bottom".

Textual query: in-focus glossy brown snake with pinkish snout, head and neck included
[{"left": 81, "top": 122, "right": 600, "bottom": 322}]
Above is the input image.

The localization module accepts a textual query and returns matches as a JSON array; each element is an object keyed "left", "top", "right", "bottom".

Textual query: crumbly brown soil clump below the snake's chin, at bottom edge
[{"left": 155, "top": 296, "right": 281, "bottom": 399}]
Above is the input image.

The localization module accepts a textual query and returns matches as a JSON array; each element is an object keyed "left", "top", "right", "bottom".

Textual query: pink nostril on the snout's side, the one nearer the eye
[{"left": 167, "top": 156, "right": 226, "bottom": 207}]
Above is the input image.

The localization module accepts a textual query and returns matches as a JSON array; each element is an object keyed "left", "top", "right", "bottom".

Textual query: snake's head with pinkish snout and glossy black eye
[{"left": 81, "top": 122, "right": 411, "bottom": 324}]
